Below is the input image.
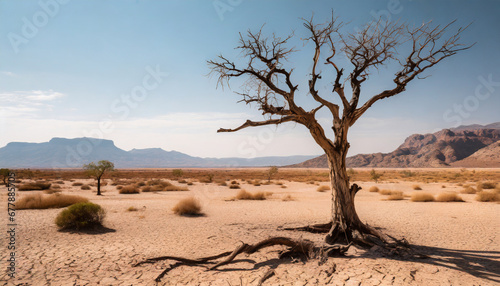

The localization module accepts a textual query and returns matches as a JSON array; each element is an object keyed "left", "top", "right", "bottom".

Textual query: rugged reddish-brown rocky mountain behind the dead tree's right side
[{"left": 292, "top": 122, "right": 500, "bottom": 168}]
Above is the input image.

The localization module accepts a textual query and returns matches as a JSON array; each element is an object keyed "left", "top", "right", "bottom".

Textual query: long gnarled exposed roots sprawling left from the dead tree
[{"left": 133, "top": 237, "right": 351, "bottom": 282}]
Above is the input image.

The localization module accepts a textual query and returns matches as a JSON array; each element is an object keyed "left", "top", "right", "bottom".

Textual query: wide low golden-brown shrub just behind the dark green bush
[{"left": 16, "top": 194, "right": 88, "bottom": 210}]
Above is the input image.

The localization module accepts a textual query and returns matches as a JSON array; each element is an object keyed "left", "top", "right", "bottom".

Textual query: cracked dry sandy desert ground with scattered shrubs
[{"left": 0, "top": 169, "right": 500, "bottom": 285}]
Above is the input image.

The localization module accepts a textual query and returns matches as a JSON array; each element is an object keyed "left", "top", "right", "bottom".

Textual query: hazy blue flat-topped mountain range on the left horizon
[{"left": 0, "top": 137, "right": 315, "bottom": 168}]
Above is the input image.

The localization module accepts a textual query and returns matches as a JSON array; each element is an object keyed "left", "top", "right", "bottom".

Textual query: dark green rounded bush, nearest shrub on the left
[{"left": 56, "top": 203, "right": 106, "bottom": 230}]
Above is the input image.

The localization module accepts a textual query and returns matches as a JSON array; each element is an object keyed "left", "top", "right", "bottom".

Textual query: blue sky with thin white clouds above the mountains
[{"left": 0, "top": 0, "right": 500, "bottom": 157}]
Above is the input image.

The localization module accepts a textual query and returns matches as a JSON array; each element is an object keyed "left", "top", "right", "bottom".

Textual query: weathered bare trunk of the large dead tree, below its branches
[{"left": 325, "top": 147, "right": 383, "bottom": 244}]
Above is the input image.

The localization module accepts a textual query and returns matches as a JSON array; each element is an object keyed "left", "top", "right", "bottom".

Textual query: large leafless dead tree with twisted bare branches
[{"left": 208, "top": 16, "right": 471, "bottom": 244}]
